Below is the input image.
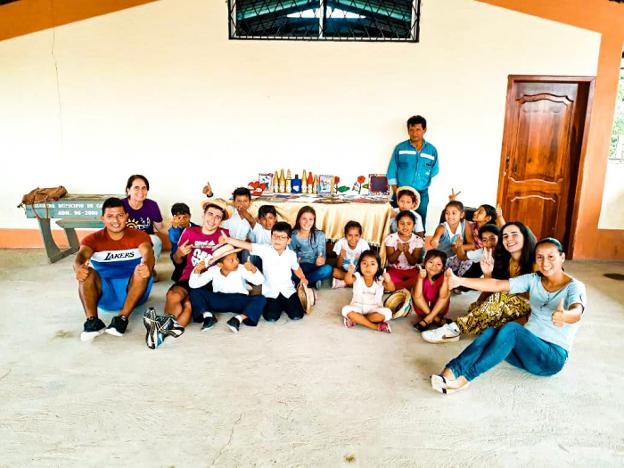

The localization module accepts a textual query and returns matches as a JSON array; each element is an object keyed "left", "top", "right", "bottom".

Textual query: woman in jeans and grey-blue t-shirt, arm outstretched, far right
[{"left": 431, "top": 237, "right": 587, "bottom": 393}]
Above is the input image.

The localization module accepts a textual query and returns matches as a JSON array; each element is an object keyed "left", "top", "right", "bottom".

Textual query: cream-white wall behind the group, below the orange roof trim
[{"left": 0, "top": 0, "right": 600, "bottom": 231}]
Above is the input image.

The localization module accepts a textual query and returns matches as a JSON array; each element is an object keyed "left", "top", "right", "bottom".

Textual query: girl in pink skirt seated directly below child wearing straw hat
[{"left": 384, "top": 211, "right": 425, "bottom": 289}]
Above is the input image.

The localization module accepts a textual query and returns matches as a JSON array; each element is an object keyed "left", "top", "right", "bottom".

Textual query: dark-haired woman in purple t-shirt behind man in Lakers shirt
[{"left": 122, "top": 174, "right": 167, "bottom": 261}]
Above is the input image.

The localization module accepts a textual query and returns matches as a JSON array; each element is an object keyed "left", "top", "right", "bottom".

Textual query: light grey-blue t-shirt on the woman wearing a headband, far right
[{"left": 509, "top": 273, "right": 587, "bottom": 352}]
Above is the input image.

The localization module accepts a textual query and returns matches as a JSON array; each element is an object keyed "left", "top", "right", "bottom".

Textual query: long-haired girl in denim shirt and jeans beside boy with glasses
[{"left": 289, "top": 206, "right": 333, "bottom": 289}]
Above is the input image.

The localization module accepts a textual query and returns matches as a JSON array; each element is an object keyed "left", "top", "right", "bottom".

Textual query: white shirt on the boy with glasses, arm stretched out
[{"left": 251, "top": 243, "right": 299, "bottom": 299}]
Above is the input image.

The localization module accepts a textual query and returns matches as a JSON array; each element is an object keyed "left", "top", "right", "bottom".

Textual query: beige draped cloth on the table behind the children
[{"left": 249, "top": 197, "right": 392, "bottom": 262}]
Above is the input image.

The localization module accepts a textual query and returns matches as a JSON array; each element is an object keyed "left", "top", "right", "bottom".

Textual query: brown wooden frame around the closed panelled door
[{"left": 496, "top": 75, "right": 596, "bottom": 259}]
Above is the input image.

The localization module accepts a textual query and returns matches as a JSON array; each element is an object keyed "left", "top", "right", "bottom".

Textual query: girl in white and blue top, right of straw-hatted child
[{"left": 431, "top": 200, "right": 475, "bottom": 276}]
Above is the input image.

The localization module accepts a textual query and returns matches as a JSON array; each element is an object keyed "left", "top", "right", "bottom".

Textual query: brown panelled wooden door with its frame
[{"left": 497, "top": 75, "right": 594, "bottom": 256}]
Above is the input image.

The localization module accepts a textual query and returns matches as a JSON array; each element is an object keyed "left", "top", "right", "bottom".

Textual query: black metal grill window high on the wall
[{"left": 228, "top": 0, "right": 421, "bottom": 42}]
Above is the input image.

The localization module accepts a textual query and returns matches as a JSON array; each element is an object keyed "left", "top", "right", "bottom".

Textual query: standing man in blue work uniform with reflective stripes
[{"left": 386, "top": 115, "right": 439, "bottom": 225}]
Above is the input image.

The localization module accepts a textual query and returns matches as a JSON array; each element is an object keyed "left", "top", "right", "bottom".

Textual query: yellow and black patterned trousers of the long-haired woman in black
[{"left": 455, "top": 292, "right": 531, "bottom": 335}]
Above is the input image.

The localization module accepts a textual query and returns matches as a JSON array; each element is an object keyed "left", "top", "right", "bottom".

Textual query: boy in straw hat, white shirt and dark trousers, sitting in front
[{"left": 189, "top": 244, "right": 266, "bottom": 333}]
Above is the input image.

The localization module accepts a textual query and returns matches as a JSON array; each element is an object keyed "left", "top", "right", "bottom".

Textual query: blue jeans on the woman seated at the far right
[{"left": 446, "top": 322, "right": 568, "bottom": 380}]
